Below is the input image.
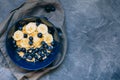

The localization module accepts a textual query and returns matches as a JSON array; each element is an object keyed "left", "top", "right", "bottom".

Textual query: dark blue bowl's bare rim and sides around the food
[{"left": 6, "top": 17, "right": 60, "bottom": 70}]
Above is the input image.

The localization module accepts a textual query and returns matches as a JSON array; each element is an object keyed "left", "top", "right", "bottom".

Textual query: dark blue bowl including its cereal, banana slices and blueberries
[{"left": 6, "top": 17, "right": 60, "bottom": 70}]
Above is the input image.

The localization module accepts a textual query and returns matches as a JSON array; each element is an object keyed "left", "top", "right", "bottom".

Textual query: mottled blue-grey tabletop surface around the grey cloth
[{"left": 0, "top": 0, "right": 120, "bottom": 80}]
